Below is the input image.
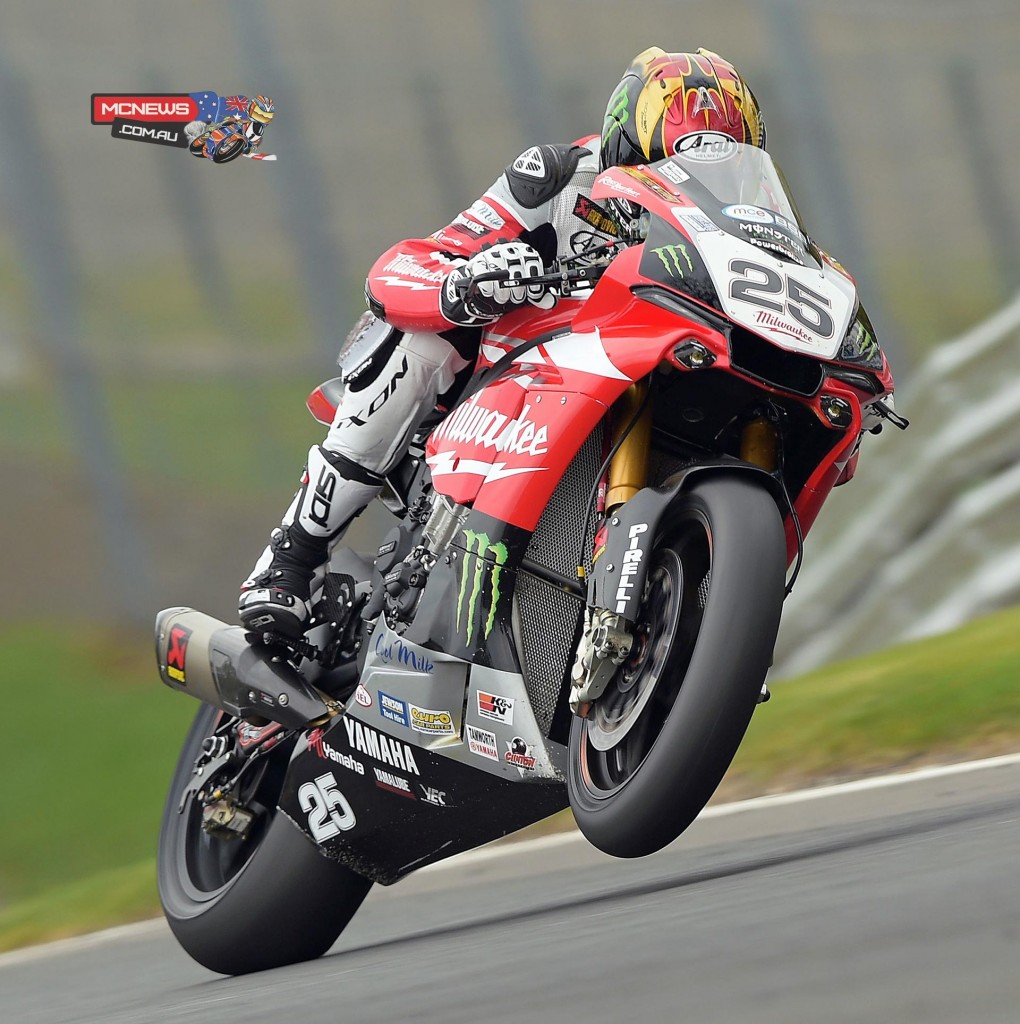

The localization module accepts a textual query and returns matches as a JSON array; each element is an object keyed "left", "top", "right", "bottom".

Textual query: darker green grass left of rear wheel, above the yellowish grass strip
[{"left": 0, "top": 624, "right": 198, "bottom": 905}]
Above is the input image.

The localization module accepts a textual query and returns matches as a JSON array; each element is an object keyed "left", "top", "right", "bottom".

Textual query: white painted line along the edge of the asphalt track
[{"left": 0, "top": 754, "right": 1020, "bottom": 968}]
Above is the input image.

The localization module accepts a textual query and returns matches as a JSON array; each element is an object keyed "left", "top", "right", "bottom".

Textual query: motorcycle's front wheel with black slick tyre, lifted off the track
[{"left": 567, "top": 475, "right": 787, "bottom": 857}]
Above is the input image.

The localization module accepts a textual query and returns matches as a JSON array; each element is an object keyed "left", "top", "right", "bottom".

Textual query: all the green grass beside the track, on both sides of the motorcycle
[{"left": 0, "top": 608, "right": 1020, "bottom": 949}]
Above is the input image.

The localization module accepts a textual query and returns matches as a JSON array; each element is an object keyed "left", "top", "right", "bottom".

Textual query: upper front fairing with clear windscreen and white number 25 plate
[{"left": 593, "top": 142, "right": 881, "bottom": 369}]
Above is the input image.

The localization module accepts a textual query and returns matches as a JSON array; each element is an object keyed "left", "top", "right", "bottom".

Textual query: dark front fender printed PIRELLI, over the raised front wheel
[{"left": 588, "top": 459, "right": 787, "bottom": 622}]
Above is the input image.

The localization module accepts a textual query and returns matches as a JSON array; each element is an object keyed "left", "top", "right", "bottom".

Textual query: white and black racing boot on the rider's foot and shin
[{"left": 238, "top": 444, "right": 382, "bottom": 639}]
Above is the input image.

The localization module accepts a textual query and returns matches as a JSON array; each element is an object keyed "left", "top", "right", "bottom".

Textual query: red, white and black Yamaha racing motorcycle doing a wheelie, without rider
[{"left": 156, "top": 138, "right": 906, "bottom": 974}]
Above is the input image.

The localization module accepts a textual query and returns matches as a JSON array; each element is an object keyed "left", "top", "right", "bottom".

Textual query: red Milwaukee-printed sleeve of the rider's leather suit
[{"left": 366, "top": 197, "right": 524, "bottom": 333}]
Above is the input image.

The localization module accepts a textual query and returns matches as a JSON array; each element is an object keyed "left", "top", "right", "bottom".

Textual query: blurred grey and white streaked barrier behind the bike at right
[{"left": 773, "top": 294, "right": 1020, "bottom": 676}]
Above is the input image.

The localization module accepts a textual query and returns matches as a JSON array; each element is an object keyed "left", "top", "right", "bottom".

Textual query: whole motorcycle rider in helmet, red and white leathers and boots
[{"left": 239, "top": 47, "right": 765, "bottom": 638}]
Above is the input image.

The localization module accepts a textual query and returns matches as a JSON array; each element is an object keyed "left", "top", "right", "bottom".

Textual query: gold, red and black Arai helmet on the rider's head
[{"left": 600, "top": 46, "right": 765, "bottom": 170}]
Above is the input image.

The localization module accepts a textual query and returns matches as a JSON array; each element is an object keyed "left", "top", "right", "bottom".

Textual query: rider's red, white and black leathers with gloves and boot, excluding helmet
[{"left": 239, "top": 136, "right": 620, "bottom": 637}]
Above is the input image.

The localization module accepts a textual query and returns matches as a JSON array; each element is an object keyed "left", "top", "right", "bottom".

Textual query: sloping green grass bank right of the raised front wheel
[{"left": 729, "top": 608, "right": 1020, "bottom": 792}]
